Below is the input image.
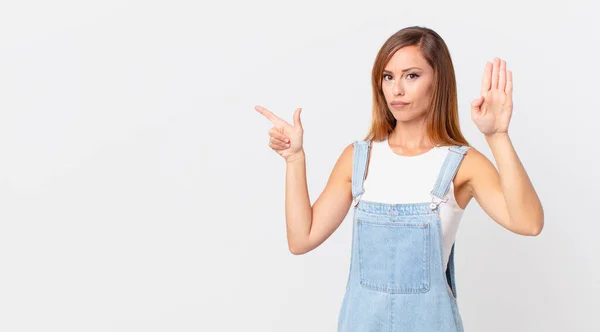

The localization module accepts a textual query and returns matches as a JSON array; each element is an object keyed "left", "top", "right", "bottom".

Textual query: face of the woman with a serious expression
[{"left": 381, "top": 46, "right": 433, "bottom": 122}]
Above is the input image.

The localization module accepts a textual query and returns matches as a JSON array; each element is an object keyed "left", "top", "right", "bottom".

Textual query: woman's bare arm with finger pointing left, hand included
[{"left": 255, "top": 106, "right": 354, "bottom": 255}]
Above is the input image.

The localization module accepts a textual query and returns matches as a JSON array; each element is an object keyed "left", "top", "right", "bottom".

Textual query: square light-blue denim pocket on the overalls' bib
[{"left": 357, "top": 217, "right": 430, "bottom": 294}]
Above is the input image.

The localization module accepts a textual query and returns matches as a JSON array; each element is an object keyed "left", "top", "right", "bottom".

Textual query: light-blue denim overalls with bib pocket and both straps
[{"left": 338, "top": 140, "right": 469, "bottom": 332}]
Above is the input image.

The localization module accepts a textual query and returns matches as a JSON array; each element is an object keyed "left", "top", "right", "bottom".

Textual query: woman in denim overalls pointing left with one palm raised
[{"left": 256, "top": 27, "right": 544, "bottom": 332}]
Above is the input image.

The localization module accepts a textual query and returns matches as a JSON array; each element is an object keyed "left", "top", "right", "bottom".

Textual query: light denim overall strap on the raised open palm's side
[{"left": 431, "top": 145, "right": 470, "bottom": 209}]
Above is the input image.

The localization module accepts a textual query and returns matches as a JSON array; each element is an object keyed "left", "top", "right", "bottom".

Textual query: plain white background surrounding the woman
[{"left": 0, "top": 0, "right": 600, "bottom": 332}]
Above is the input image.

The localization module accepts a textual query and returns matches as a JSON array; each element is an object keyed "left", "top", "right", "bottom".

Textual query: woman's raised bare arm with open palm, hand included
[{"left": 466, "top": 58, "right": 544, "bottom": 236}]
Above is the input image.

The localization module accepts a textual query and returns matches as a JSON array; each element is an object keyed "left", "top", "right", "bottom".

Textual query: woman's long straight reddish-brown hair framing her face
[{"left": 365, "top": 26, "right": 469, "bottom": 145}]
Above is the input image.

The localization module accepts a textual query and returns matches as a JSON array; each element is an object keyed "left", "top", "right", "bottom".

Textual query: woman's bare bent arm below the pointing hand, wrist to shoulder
[{"left": 285, "top": 144, "right": 354, "bottom": 255}]
